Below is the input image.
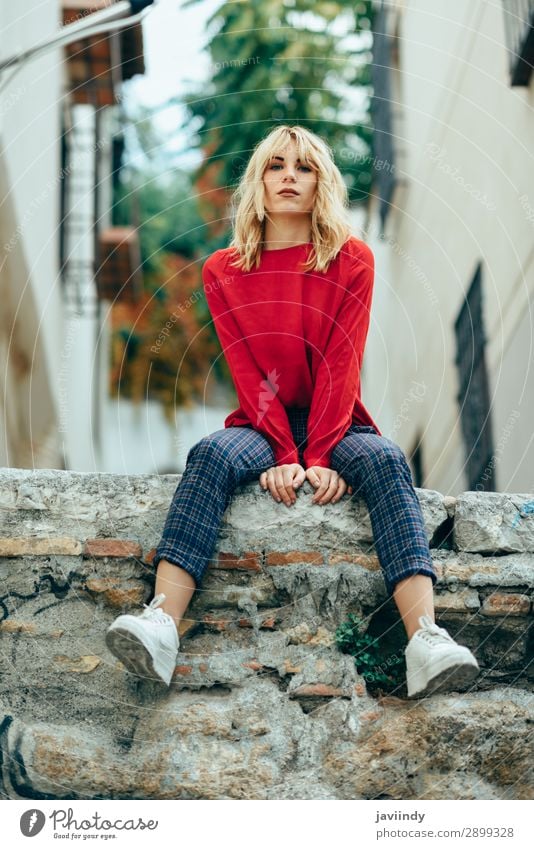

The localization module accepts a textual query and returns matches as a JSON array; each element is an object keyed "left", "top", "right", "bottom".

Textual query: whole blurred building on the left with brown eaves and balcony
[{"left": 0, "top": 0, "right": 144, "bottom": 471}]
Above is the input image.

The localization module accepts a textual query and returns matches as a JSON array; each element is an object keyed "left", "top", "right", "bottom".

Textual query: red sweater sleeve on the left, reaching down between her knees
[{"left": 202, "top": 260, "right": 299, "bottom": 465}]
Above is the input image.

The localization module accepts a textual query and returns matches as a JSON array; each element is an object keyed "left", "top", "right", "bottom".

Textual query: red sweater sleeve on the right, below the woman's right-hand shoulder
[{"left": 303, "top": 245, "right": 374, "bottom": 468}]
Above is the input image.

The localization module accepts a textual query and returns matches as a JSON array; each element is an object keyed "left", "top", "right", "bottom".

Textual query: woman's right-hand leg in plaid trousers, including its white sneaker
[{"left": 331, "top": 428, "right": 480, "bottom": 698}]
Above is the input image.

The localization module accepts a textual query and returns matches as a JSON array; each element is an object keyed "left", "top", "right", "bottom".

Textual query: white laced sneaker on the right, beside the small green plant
[{"left": 404, "top": 615, "right": 480, "bottom": 698}]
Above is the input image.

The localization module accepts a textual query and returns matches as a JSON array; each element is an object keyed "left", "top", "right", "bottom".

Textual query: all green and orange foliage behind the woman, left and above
[{"left": 111, "top": 0, "right": 378, "bottom": 416}]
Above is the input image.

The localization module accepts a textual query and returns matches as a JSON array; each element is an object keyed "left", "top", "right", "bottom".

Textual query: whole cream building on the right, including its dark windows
[{"left": 364, "top": 0, "right": 534, "bottom": 494}]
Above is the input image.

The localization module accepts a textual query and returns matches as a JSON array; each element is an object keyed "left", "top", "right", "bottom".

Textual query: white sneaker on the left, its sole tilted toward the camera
[{"left": 106, "top": 593, "right": 180, "bottom": 686}]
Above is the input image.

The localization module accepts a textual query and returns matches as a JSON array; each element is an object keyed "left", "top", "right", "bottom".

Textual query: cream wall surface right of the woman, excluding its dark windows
[{"left": 363, "top": 0, "right": 534, "bottom": 494}]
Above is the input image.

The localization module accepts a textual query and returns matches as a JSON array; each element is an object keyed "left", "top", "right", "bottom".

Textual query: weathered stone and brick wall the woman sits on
[{"left": 0, "top": 469, "right": 534, "bottom": 799}]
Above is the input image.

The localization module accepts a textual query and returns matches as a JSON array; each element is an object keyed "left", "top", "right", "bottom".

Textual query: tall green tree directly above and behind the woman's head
[{"left": 180, "top": 0, "right": 372, "bottom": 203}]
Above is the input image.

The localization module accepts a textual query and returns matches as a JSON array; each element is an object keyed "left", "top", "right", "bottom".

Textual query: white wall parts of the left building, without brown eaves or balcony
[{"left": 0, "top": 0, "right": 127, "bottom": 471}]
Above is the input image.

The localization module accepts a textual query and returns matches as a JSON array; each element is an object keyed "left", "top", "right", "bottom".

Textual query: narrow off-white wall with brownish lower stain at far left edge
[{"left": 0, "top": 0, "right": 63, "bottom": 467}]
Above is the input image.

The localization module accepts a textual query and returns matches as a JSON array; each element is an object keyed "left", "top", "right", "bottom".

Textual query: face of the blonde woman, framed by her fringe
[{"left": 263, "top": 139, "right": 317, "bottom": 214}]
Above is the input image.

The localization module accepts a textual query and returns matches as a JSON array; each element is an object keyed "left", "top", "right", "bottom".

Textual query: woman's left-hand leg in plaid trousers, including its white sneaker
[{"left": 106, "top": 427, "right": 274, "bottom": 686}]
